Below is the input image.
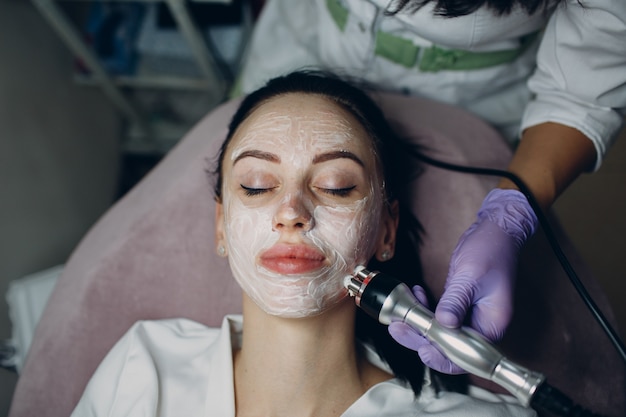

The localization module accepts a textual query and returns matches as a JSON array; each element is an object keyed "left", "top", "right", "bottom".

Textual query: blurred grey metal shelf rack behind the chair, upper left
[{"left": 31, "top": 0, "right": 253, "bottom": 153}]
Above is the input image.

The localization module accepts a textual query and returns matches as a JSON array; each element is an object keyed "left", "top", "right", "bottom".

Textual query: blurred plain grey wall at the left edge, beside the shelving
[{"left": 0, "top": 0, "right": 120, "bottom": 410}]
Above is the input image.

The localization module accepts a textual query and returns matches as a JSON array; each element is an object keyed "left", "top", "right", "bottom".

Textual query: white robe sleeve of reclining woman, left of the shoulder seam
[{"left": 71, "top": 322, "right": 158, "bottom": 417}]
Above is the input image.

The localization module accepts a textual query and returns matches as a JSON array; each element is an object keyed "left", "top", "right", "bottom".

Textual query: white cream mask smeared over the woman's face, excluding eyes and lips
[{"left": 222, "top": 102, "right": 383, "bottom": 318}]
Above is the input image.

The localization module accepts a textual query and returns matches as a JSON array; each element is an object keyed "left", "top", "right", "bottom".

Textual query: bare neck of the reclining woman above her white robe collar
[{"left": 234, "top": 299, "right": 391, "bottom": 417}]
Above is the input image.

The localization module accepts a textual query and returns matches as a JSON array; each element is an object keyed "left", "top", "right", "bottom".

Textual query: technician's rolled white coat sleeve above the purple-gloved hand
[{"left": 521, "top": 0, "right": 626, "bottom": 169}]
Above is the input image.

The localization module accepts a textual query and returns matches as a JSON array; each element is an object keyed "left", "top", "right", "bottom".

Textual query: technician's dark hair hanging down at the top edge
[{"left": 385, "top": 0, "right": 562, "bottom": 17}]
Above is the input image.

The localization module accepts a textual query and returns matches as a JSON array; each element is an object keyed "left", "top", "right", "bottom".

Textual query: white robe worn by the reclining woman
[{"left": 72, "top": 315, "right": 536, "bottom": 417}]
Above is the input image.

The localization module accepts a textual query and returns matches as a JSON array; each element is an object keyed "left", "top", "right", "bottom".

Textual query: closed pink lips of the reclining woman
[{"left": 260, "top": 244, "right": 326, "bottom": 275}]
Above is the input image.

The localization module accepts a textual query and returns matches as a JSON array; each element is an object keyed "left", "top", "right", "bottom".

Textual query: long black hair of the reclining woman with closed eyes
[{"left": 214, "top": 70, "right": 467, "bottom": 396}]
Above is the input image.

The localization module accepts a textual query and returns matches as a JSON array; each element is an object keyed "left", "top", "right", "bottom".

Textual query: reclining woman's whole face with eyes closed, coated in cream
[{"left": 217, "top": 93, "right": 387, "bottom": 317}]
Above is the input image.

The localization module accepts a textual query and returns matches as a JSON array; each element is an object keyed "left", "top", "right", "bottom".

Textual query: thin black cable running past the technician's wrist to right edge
[{"left": 410, "top": 151, "right": 626, "bottom": 364}]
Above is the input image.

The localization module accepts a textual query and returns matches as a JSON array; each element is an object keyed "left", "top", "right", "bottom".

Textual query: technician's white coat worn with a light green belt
[{"left": 239, "top": 0, "right": 626, "bottom": 168}]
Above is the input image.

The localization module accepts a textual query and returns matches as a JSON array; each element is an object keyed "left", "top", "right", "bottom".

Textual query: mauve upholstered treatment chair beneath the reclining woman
[{"left": 10, "top": 90, "right": 626, "bottom": 417}]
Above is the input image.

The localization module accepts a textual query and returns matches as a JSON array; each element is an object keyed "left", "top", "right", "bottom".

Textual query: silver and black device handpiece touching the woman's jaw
[{"left": 346, "top": 266, "right": 545, "bottom": 407}]
